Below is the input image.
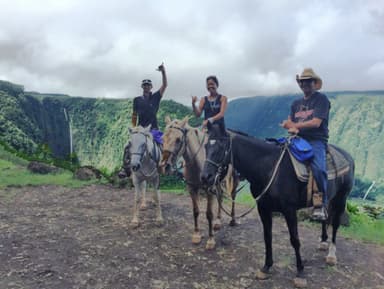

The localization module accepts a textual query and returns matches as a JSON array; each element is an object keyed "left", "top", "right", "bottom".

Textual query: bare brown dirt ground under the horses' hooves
[{"left": 0, "top": 185, "right": 384, "bottom": 289}]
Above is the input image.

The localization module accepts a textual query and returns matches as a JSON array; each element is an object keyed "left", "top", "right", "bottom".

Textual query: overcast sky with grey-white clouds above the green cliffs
[{"left": 0, "top": 0, "right": 384, "bottom": 103}]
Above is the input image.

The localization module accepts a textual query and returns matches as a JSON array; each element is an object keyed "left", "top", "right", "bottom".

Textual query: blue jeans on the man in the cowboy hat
[{"left": 308, "top": 140, "right": 328, "bottom": 205}]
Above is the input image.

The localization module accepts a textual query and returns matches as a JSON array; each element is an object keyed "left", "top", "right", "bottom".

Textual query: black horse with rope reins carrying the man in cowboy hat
[{"left": 202, "top": 121, "right": 354, "bottom": 284}]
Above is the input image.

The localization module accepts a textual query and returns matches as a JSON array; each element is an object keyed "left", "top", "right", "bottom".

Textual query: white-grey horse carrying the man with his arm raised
[{"left": 128, "top": 126, "right": 163, "bottom": 227}]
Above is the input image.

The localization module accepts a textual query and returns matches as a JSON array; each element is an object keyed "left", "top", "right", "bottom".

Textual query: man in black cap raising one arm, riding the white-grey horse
[{"left": 119, "top": 63, "right": 168, "bottom": 178}]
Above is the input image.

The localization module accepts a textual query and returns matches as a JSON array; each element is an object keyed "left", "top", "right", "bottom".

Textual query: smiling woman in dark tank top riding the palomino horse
[{"left": 192, "top": 75, "right": 228, "bottom": 128}]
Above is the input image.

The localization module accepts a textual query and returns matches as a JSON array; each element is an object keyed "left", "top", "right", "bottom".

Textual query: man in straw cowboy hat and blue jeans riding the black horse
[{"left": 282, "top": 68, "right": 331, "bottom": 221}]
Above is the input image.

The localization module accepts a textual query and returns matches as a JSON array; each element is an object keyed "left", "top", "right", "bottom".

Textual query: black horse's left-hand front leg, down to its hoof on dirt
[{"left": 256, "top": 205, "right": 273, "bottom": 280}]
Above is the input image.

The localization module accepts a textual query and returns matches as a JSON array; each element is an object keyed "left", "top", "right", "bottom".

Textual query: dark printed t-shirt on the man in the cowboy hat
[{"left": 291, "top": 91, "right": 331, "bottom": 141}]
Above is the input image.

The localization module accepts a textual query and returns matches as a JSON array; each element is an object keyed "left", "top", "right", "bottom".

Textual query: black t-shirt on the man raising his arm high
[{"left": 133, "top": 90, "right": 161, "bottom": 129}]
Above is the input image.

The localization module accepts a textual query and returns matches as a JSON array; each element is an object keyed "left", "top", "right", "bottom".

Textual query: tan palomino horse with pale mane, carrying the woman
[{"left": 162, "top": 117, "right": 238, "bottom": 249}]
